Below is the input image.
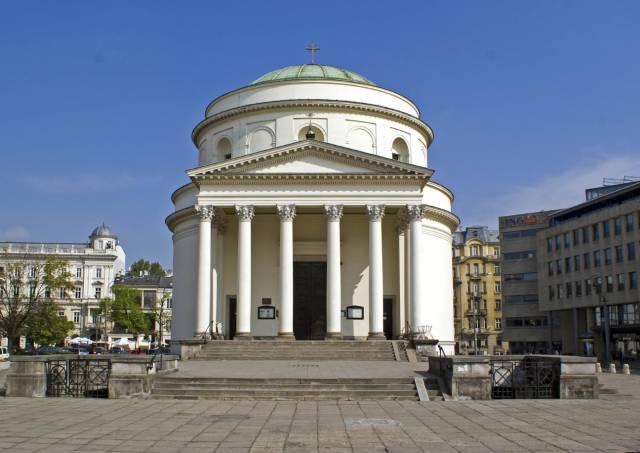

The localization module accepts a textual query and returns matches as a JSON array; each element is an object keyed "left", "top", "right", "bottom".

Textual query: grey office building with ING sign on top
[{"left": 499, "top": 211, "right": 561, "bottom": 354}]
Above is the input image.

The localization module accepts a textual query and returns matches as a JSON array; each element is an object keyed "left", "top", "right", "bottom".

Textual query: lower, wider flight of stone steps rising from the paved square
[{"left": 151, "top": 376, "right": 420, "bottom": 401}]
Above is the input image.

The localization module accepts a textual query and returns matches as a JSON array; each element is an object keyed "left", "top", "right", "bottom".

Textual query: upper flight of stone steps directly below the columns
[{"left": 193, "top": 340, "right": 406, "bottom": 361}]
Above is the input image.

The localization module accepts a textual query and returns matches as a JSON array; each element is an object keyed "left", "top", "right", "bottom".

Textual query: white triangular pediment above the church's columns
[{"left": 187, "top": 140, "right": 433, "bottom": 180}]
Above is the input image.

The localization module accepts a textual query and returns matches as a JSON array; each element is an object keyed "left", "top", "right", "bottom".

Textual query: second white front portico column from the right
[{"left": 367, "top": 205, "right": 385, "bottom": 340}]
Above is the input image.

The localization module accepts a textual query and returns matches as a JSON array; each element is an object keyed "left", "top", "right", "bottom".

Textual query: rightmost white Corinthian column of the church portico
[{"left": 407, "top": 205, "right": 427, "bottom": 332}]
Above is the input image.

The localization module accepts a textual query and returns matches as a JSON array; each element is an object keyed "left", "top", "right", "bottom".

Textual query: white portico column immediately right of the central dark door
[{"left": 324, "top": 205, "right": 342, "bottom": 339}]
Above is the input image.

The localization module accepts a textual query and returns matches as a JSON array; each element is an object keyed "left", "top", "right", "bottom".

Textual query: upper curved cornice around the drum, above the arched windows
[{"left": 191, "top": 99, "right": 434, "bottom": 148}]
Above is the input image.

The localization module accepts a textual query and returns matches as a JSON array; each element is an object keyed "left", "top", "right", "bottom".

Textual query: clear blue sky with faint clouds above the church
[{"left": 0, "top": 0, "right": 640, "bottom": 267}]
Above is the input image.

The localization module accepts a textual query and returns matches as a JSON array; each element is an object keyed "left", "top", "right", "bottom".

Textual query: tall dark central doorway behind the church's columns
[{"left": 293, "top": 261, "right": 327, "bottom": 340}]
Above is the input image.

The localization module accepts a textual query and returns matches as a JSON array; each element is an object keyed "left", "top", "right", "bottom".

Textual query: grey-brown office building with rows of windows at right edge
[{"left": 537, "top": 182, "right": 640, "bottom": 361}]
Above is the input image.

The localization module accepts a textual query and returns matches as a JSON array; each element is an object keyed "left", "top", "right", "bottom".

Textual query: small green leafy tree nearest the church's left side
[{"left": 106, "top": 285, "right": 149, "bottom": 334}]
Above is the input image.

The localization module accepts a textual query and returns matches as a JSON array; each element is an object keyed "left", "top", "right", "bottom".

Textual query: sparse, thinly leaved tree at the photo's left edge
[{"left": 0, "top": 257, "right": 74, "bottom": 350}]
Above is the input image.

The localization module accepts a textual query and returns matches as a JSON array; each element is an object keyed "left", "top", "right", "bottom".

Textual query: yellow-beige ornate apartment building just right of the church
[{"left": 453, "top": 226, "right": 507, "bottom": 355}]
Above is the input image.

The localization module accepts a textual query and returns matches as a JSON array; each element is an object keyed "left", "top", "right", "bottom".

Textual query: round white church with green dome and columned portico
[{"left": 166, "top": 64, "right": 459, "bottom": 353}]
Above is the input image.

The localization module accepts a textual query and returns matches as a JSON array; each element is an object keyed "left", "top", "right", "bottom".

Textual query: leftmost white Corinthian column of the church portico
[{"left": 193, "top": 206, "right": 214, "bottom": 336}]
